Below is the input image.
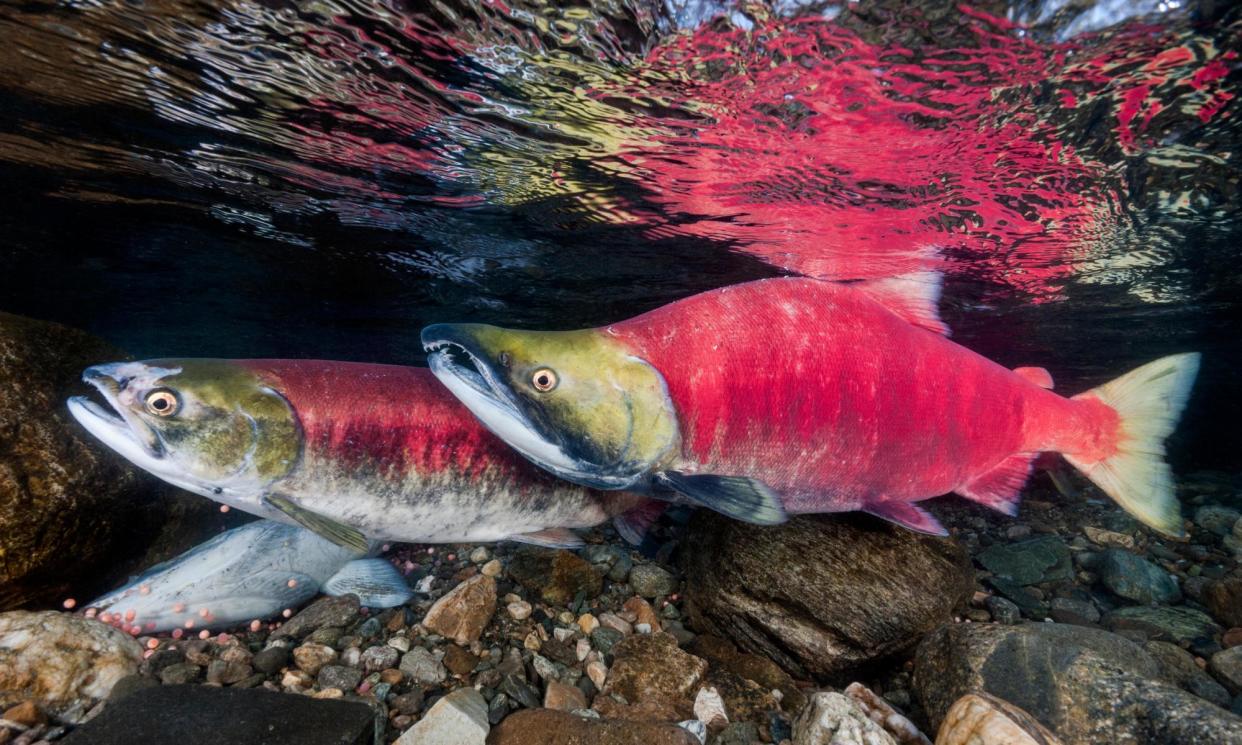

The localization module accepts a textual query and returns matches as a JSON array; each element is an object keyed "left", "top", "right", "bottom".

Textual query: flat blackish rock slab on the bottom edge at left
[{"left": 62, "top": 685, "right": 375, "bottom": 745}]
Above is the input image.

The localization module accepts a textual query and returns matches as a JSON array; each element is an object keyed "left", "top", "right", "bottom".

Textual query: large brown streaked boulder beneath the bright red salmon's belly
[{"left": 686, "top": 510, "right": 974, "bottom": 678}]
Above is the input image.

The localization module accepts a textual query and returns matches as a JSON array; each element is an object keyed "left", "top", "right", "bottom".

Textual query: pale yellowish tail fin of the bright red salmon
[{"left": 1064, "top": 353, "right": 1199, "bottom": 536}]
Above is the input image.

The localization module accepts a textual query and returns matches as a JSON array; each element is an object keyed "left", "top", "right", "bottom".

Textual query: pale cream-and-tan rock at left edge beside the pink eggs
[{"left": 0, "top": 611, "right": 143, "bottom": 723}]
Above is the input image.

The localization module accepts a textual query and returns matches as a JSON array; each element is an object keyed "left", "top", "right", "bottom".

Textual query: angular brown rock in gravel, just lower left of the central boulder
[{"left": 596, "top": 632, "right": 708, "bottom": 719}]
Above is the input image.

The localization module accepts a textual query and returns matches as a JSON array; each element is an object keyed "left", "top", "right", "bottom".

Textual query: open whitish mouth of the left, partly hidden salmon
[{"left": 68, "top": 363, "right": 168, "bottom": 468}]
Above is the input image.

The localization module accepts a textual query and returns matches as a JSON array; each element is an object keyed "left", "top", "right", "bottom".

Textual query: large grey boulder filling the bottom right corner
[{"left": 914, "top": 623, "right": 1242, "bottom": 745}]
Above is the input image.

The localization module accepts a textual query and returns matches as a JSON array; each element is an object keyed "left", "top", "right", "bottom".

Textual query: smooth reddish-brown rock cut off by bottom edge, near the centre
[{"left": 487, "top": 709, "right": 698, "bottom": 745}]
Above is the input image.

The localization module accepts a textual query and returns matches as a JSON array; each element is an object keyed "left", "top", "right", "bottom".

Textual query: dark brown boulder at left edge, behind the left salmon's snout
[{"left": 0, "top": 313, "right": 232, "bottom": 611}]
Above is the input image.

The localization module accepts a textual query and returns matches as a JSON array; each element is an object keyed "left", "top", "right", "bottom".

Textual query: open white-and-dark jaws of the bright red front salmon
[{"left": 422, "top": 324, "right": 617, "bottom": 488}]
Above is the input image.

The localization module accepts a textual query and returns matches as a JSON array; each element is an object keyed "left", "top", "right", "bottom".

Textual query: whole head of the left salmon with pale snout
[{"left": 68, "top": 359, "right": 302, "bottom": 509}]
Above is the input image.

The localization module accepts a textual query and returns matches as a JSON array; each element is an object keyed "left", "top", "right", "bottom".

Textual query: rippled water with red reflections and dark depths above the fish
[{"left": 0, "top": 0, "right": 1242, "bottom": 467}]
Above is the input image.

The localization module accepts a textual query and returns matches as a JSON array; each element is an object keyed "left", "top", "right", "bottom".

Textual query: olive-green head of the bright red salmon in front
[{"left": 422, "top": 324, "right": 681, "bottom": 489}]
